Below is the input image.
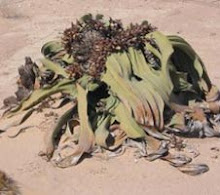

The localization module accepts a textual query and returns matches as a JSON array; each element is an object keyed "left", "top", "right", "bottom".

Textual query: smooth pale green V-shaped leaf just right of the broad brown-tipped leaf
[{"left": 129, "top": 31, "right": 173, "bottom": 104}]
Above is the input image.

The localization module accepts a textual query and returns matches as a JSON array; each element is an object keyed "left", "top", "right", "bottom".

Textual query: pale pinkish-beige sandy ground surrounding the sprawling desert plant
[{"left": 0, "top": 0, "right": 220, "bottom": 195}]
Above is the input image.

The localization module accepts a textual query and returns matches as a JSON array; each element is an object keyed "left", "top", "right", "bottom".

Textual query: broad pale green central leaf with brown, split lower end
[{"left": 102, "top": 43, "right": 164, "bottom": 129}]
